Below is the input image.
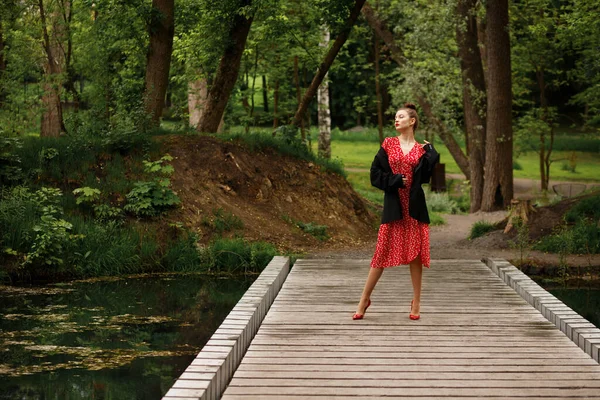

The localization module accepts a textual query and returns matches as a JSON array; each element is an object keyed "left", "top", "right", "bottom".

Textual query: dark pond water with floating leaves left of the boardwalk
[{"left": 0, "top": 275, "right": 252, "bottom": 400}]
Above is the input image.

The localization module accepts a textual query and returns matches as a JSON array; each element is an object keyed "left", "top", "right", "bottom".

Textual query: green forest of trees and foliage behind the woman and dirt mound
[{"left": 0, "top": 0, "right": 600, "bottom": 282}]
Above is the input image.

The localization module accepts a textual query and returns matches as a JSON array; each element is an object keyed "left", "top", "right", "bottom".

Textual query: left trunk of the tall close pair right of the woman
[{"left": 456, "top": 0, "right": 486, "bottom": 213}]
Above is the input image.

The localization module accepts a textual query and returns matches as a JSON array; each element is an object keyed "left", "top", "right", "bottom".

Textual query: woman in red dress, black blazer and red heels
[{"left": 352, "top": 103, "right": 439, "bottom": 320}]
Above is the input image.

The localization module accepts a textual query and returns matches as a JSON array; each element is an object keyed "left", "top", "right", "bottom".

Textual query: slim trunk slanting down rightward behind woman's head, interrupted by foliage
[{"left": 363, "top": 0, "right": 471, "bottom": 179}]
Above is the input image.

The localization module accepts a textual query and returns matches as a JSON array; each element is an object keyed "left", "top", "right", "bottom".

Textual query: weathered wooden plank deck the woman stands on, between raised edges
[{"left": 222, "top": 259, "right": 600, "bottom": 400}]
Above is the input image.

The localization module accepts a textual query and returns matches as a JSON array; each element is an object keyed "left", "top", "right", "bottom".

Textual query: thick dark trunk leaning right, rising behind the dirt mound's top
[{"left": 198, "top": 0, "right": 253, "bottom": 132}]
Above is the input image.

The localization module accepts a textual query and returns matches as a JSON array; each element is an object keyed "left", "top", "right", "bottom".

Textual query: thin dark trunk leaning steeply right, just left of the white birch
[{"left": 292, "top": 0, "right": 365, "bottom": 126}]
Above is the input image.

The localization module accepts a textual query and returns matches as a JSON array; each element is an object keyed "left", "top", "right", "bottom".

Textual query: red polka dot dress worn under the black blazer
[{"left": 371, "top": 137, "right": 430, "bottom": 268}]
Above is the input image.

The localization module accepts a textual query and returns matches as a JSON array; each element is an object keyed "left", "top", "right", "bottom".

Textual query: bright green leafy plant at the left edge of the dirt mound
[{"left": 124, "top": 154, "right": 181, "bottom": 217}]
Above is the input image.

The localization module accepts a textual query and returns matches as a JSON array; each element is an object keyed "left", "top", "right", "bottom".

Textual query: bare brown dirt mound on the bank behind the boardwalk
[{"left": 161, "top": 135, "right": 377, "bottom": 251}]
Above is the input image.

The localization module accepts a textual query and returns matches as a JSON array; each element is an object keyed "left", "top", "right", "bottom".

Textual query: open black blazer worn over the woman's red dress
[{"left": 371, "top": 144, "right": 440, "bottom": 224}]
